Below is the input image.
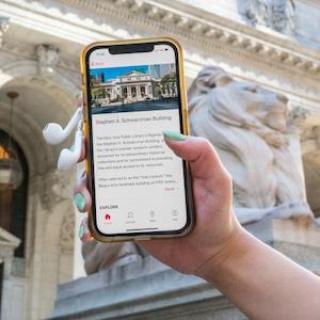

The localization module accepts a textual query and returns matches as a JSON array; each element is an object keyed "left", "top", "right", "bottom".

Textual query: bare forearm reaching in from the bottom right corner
[{"left": 201, "top": 231, "right": 320, "bottom": 320}]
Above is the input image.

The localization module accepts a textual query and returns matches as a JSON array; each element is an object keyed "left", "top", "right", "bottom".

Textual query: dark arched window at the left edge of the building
[{"left": 0, "top": 130, "right": 28, "bottom": 257}]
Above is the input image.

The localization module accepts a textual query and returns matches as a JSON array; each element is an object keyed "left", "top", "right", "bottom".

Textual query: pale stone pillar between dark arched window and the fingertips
[{"left": 28, "top": 169, "right": 74, "bottom": 320}]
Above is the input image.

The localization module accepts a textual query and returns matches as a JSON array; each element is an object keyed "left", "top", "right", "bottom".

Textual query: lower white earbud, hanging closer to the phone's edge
[{"left": 58, "top": 124, "right": 82, "bottom": 170}]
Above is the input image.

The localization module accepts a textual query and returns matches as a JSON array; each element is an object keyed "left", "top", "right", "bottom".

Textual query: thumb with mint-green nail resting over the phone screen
[{"left": 163, "top": 131, "right": 229, "bottom": 179}]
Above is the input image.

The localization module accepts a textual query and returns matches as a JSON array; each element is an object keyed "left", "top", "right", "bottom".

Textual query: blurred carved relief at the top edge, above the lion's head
[{"left": 238, "top": 0, "right": 296, "bottom": 33}]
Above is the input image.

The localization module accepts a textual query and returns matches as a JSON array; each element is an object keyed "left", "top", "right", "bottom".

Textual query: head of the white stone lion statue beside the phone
[{"left": 188, "top": 66, "right": 288, "bottom": 132}]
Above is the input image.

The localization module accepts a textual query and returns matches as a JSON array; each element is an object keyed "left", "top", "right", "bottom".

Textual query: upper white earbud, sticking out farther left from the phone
[{"left": 42, "top": 108, "right": 82, "bottom": 145}]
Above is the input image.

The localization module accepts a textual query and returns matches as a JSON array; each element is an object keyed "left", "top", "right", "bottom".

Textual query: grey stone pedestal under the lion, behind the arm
[{"left": 50, "top": 220, "right": 320, "bottom": 320}]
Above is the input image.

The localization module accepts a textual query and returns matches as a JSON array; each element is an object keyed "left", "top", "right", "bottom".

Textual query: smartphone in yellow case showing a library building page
[{"left": 80, "top": 38, "right": 194, "bottom": 242}]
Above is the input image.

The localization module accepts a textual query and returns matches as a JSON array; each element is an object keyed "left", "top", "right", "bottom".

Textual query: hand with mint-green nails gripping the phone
[{"left": 75, "top": 132, "right": 242, "bottom": 275}]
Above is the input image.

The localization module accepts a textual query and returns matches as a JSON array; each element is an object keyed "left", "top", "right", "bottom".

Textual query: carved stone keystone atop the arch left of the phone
[{"left": 36, "top": 44, "right": 60, "bottom": 72}]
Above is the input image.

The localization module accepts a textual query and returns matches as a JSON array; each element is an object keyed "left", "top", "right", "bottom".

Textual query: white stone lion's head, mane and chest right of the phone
[{"left": 189, "top": 66, "right": 311, "bottom": 223}]
